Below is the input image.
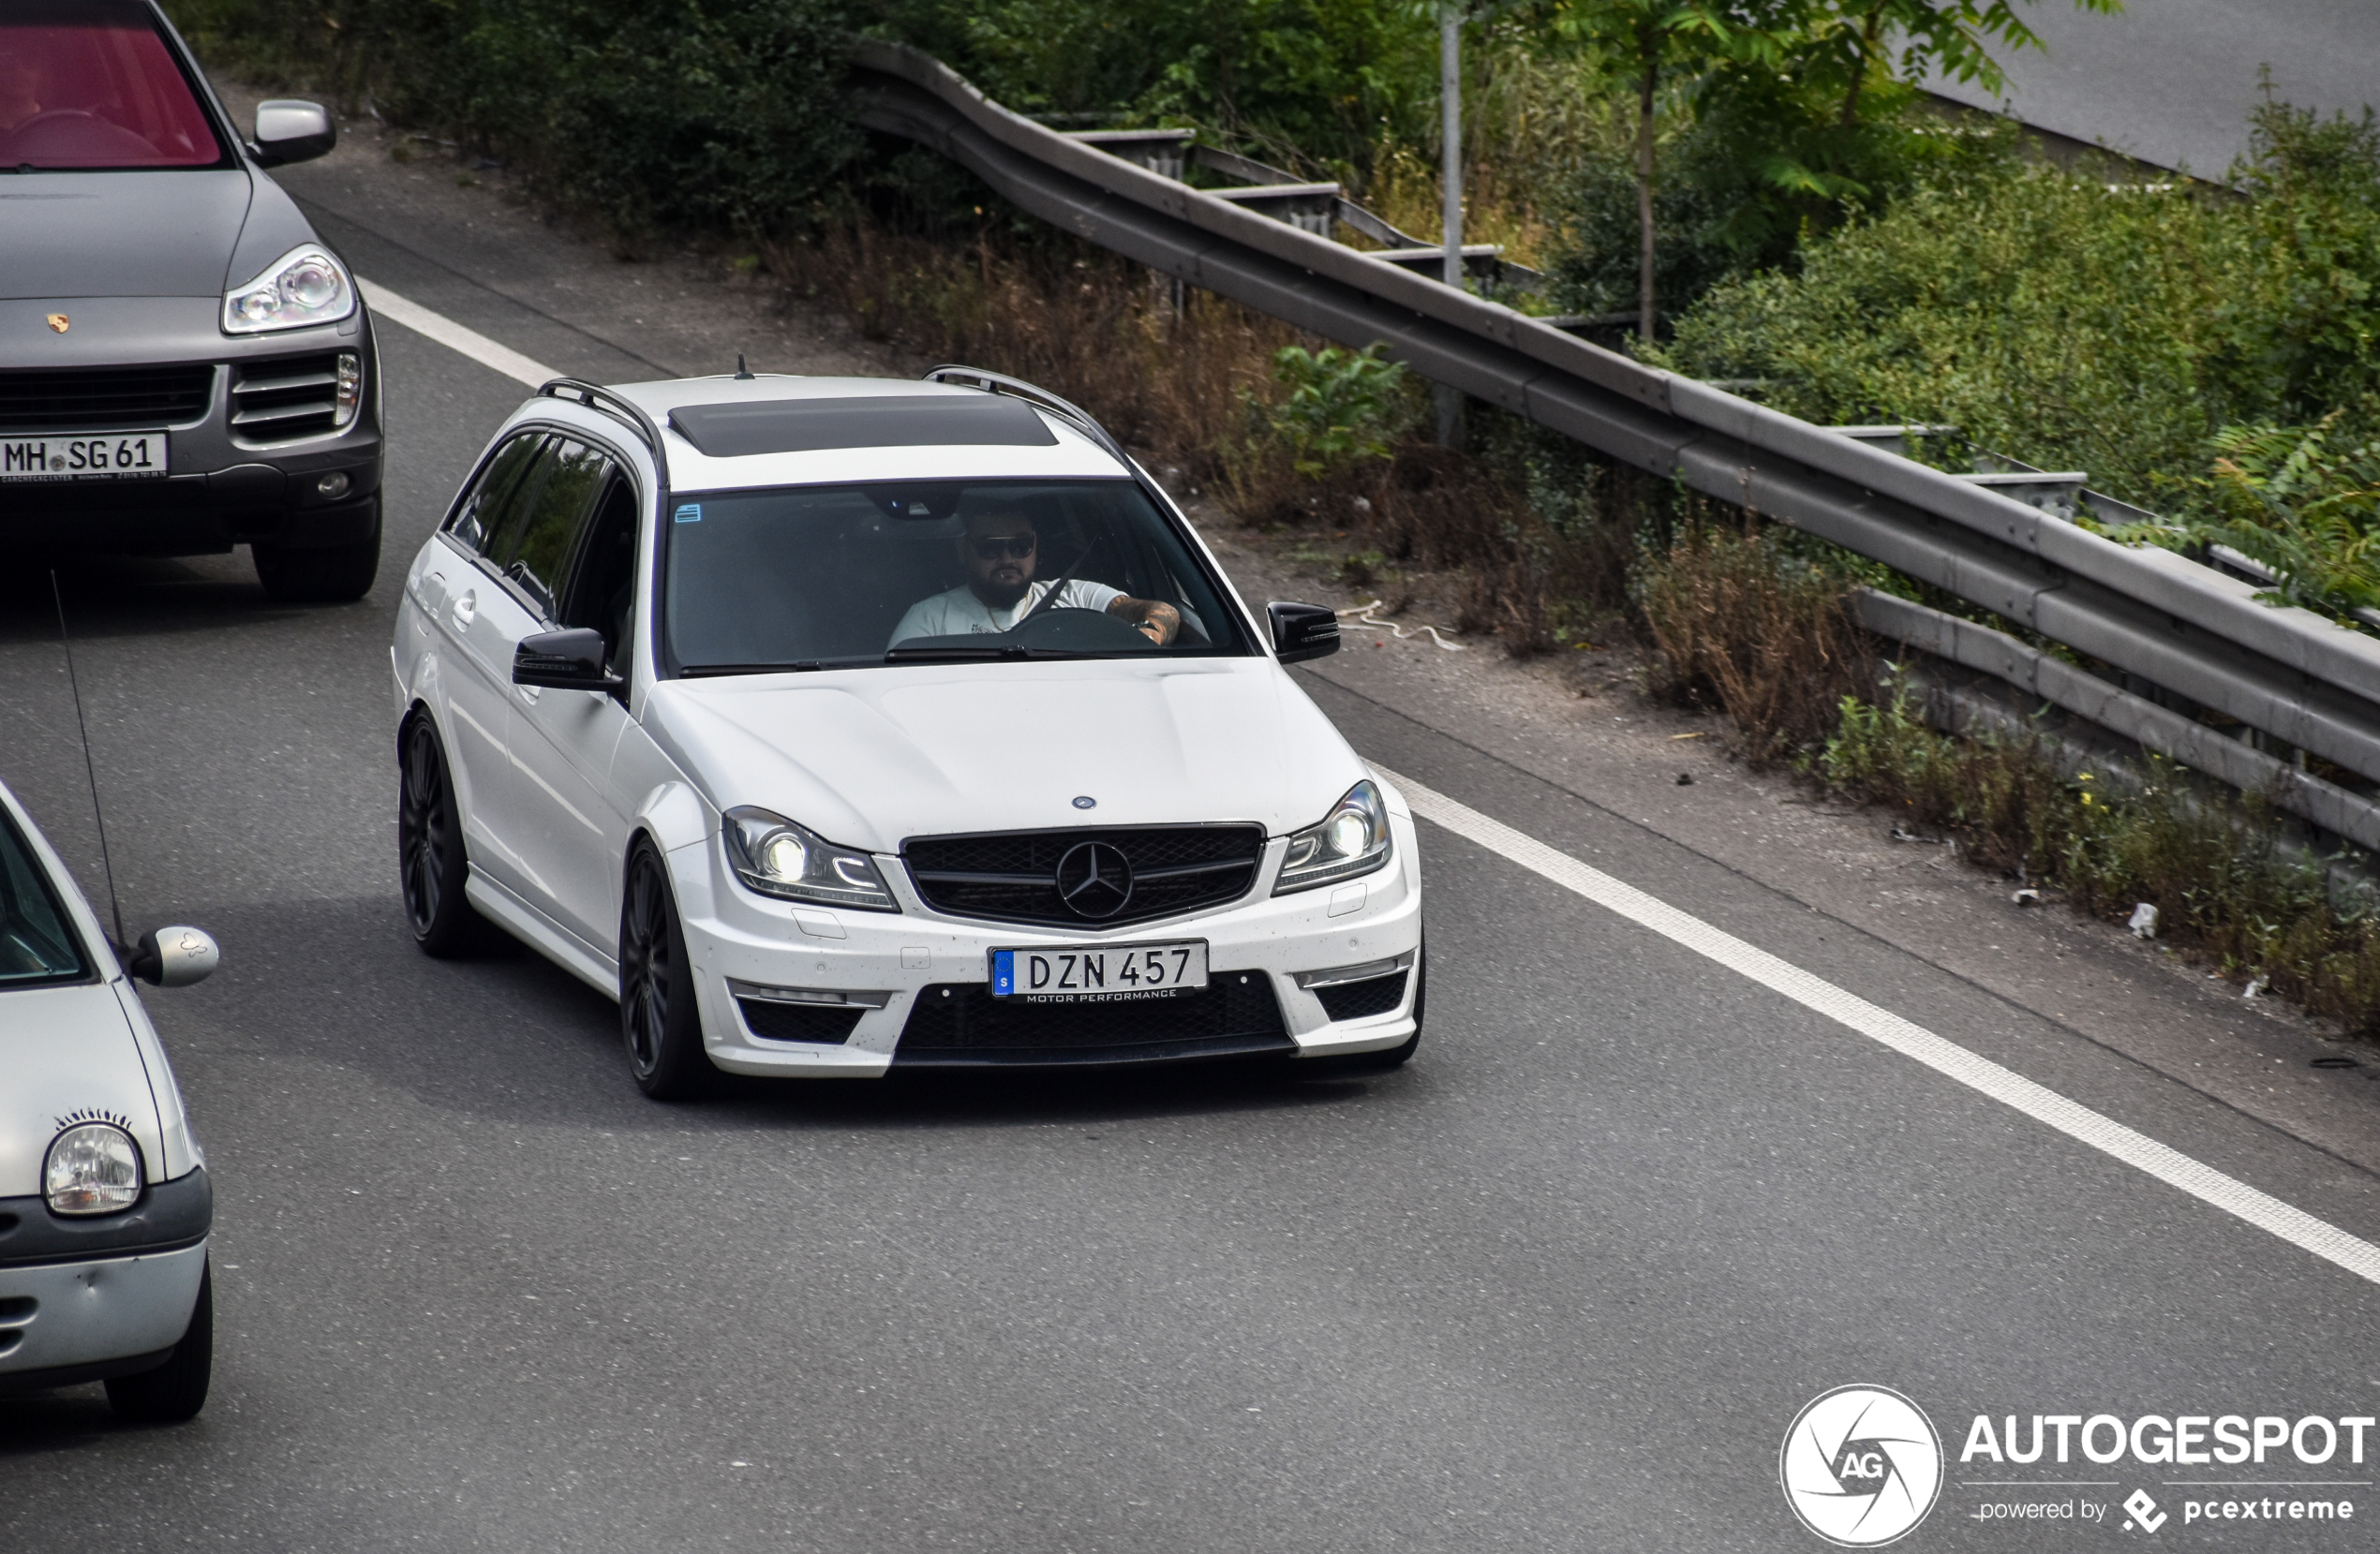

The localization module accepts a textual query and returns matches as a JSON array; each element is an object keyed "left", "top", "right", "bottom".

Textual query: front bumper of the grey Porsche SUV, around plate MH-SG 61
[{"left": 0, "top": 298, "right": 380, "bottom": 555}]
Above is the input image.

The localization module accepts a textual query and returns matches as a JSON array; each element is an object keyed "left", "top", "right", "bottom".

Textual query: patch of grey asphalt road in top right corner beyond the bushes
[{"left": 1935, "top": 0, "right": 2380, "bottom": 179}]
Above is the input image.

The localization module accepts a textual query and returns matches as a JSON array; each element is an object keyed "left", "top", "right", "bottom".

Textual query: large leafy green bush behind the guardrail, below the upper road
[{"left": 1661, "top": 105, "right": 2380, "bottom": 516}]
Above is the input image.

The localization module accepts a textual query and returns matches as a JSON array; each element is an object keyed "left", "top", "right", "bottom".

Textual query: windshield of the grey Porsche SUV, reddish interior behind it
[{"left": 0, "top": 0, "right": 224, "bottom": 171}]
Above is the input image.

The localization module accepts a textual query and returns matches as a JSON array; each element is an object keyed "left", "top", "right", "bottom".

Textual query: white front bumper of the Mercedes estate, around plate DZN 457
[{"left": 669, "top": 811, "right": 1421, "bottom": 1078}]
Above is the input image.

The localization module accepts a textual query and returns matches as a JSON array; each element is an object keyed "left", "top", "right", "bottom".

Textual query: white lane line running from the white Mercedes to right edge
[{"left": 1374, "top": 762, "right": 2380, "bottom": 1282}]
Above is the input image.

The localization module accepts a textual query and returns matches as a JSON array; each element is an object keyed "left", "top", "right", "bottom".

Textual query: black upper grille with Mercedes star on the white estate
[{"left": 902, "top": 826, "right": 1264, "bottom": 928}]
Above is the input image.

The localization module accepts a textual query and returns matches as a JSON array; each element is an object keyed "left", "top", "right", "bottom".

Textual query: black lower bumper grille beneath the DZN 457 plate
[{"left": 893, "top": 971, "right": 1297, "bottom": 1064}]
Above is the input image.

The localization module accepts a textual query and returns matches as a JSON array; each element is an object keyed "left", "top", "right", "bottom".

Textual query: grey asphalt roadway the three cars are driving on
[{"left": 0, "top": 178, "right": 2380, "bottom": 1554}]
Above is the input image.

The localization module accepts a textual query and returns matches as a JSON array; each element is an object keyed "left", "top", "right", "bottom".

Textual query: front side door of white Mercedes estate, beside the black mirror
[{"left": 507, "top": 457, "right": 643, "bottom": 959}]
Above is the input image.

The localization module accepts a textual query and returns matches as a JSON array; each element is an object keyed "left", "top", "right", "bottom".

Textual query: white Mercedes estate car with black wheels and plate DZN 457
[{"left": 393, "top": 366, "right": 1423, "bottom": 1097}]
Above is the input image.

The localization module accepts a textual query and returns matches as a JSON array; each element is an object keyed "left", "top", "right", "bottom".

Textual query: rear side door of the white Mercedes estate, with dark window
[{"left": 414, "top": 431, "right": 550, "bottom": 883}]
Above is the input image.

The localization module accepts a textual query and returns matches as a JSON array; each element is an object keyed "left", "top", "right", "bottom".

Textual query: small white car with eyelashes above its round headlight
[{"left": 0, "top": 785, "right": 216, "bottom": 1421}]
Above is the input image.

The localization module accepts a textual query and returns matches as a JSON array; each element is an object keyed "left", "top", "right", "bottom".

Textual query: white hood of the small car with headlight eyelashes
[{"left": 0, "top": 983, "right": 167, "bottom": 1197}]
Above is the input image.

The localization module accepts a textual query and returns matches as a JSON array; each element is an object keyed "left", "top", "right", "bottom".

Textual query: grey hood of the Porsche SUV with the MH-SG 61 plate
[{"left": 0, "top": 169, "right": 254, "bottom": 298}]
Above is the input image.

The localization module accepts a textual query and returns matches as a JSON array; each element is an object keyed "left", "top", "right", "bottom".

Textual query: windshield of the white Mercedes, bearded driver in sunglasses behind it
[{"left": 664, "top": 481, "right": 1247, "bottom": 676}]
